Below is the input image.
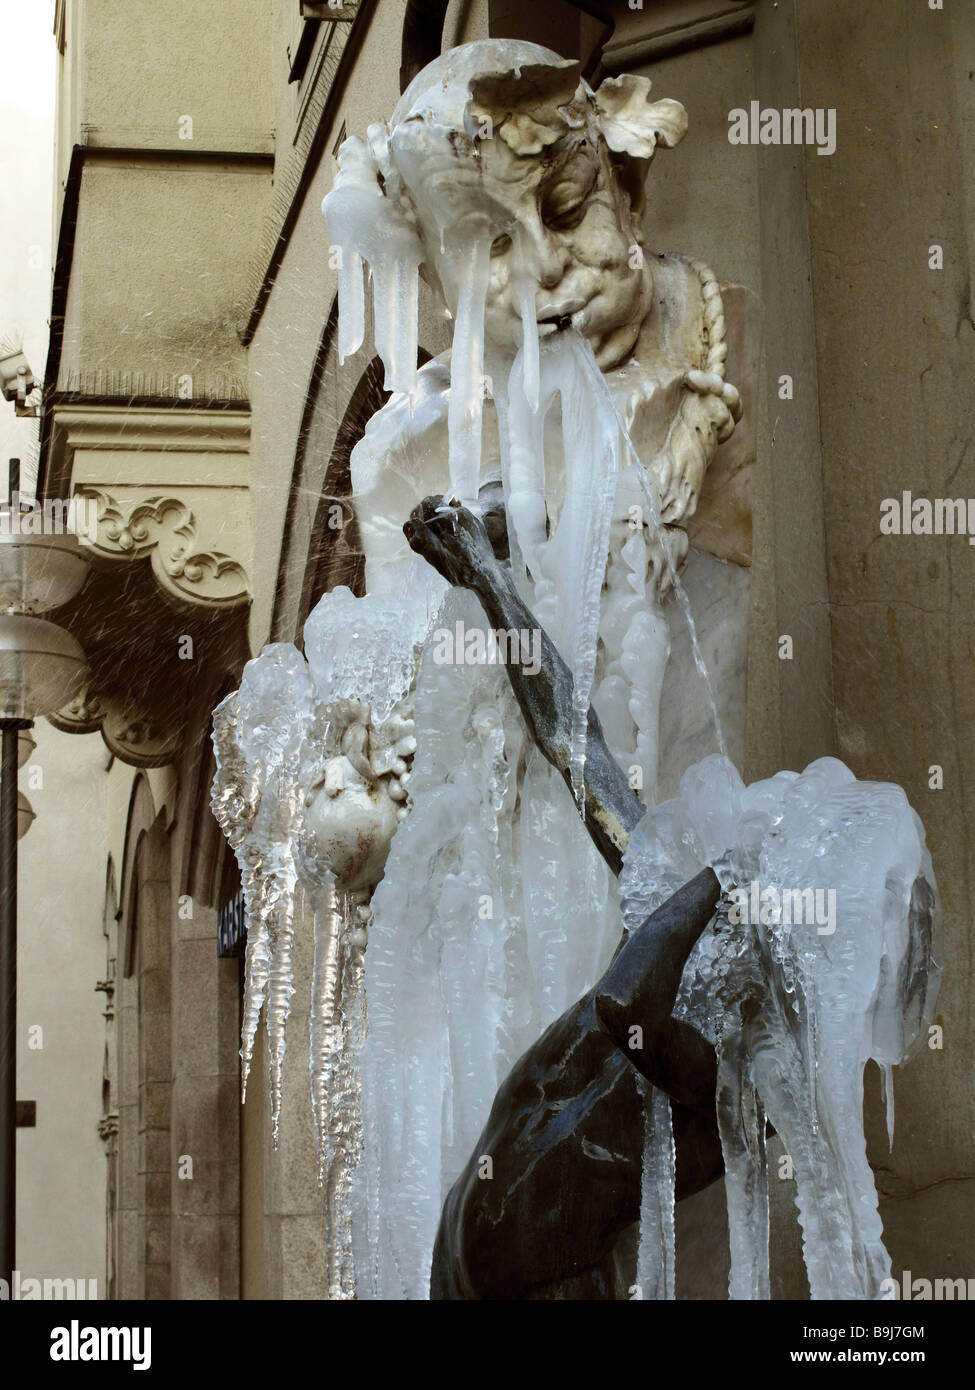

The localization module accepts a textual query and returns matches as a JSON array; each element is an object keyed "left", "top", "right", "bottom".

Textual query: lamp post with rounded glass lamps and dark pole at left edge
[{"left": 0, "top": 459, "right": 88, "bottom": 1287}]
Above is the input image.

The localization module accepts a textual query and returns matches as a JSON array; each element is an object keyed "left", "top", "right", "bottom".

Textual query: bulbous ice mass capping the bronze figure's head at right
[{"left": 620, "top": 755, "right": 936, "bottom": 1063}]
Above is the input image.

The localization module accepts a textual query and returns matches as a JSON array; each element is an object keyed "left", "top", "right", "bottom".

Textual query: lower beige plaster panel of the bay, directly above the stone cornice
[{"left": 58, "top": 158, "right": 270, "bottom": 398}]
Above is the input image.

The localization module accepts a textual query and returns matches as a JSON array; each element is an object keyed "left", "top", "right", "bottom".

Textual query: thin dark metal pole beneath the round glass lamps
[{"left": 0, "top": 719, "right": 21, "bottom": 1289}]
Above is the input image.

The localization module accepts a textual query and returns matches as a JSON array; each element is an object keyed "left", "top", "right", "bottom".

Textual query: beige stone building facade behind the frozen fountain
[{"left": 30, "top": 0, "right": 975, "bottom": 1298}]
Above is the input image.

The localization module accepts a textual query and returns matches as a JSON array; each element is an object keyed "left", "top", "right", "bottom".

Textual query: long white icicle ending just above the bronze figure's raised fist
[{"left": 446, "top": 222, "right": 491, "bottom": 502}]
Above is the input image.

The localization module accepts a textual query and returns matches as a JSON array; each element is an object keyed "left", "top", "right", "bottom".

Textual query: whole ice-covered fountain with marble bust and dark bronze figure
[{"left": 213, "top": 40, "right": 937, "bottom": 1298}]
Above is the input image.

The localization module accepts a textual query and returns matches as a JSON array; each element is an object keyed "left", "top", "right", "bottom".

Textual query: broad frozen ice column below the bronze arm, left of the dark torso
[{"left": 347, "top": 592, "right": 524, "bottom": 1298}]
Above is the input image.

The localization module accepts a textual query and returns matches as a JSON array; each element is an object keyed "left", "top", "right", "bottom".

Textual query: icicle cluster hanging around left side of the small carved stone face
[{"left": 211, "top": 589, "right": 425, "bottom": 1298}]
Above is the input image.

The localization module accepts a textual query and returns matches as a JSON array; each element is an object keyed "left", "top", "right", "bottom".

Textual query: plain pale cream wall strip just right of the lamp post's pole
[{"left": 17, "top": 720, "right": 108, "bottom": 1298}]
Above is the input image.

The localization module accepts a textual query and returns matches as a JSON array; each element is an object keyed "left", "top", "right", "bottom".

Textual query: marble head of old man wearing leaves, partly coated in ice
[{"left": 384, "top": 40, "right": 687, "bottom": 371}]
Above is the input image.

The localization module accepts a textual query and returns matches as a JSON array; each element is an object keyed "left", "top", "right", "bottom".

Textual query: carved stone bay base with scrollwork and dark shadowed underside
[{"left": 41, "top": 400, "right": 250, "bottom": 767}]
